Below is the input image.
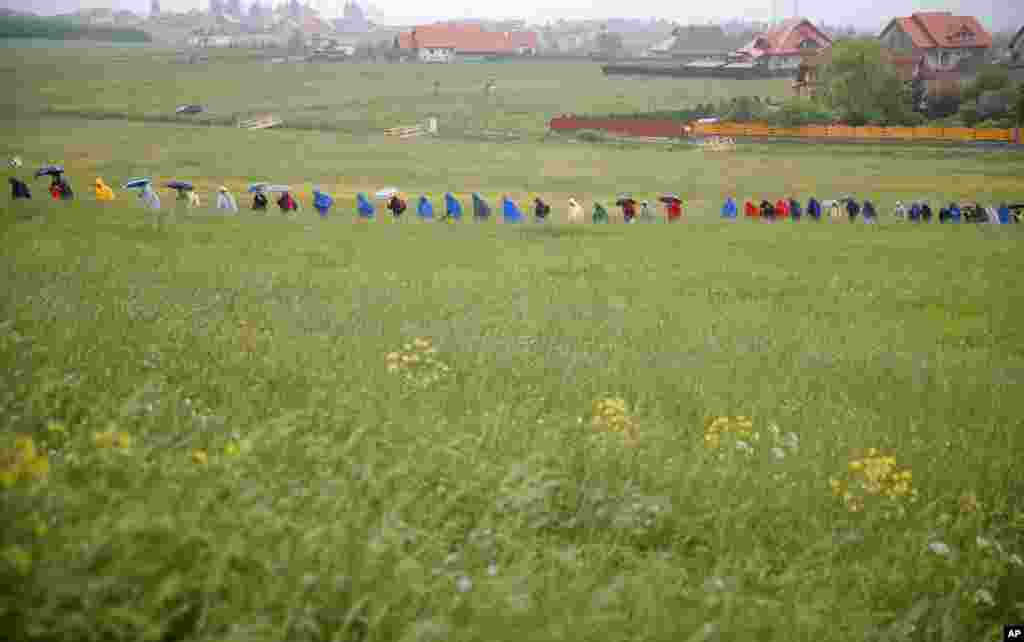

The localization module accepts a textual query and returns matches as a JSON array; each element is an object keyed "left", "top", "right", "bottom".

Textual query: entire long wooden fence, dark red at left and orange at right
[{"left": 550, "top": 116, "right": 1024, "bottom": 144}]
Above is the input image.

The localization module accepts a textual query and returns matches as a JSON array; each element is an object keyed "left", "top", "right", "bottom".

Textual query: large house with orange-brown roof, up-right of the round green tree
[{"left": 879, "top": 11, "right": 992, "bottom": 73}]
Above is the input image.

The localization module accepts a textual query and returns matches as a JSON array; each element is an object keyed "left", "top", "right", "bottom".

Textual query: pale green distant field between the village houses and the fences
[{"left": 0, "top": 48, "right": 790, "bottom": 133}]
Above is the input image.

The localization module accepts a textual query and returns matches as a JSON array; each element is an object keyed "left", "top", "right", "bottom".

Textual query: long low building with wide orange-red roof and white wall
[{"left": 394, "top": 23, "right": 538, "bottom": 62}]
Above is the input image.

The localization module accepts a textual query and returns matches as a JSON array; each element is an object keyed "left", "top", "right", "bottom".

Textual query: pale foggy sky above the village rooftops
[{"left": 0, "top": 0, "right": 1024, "bottom": 31}]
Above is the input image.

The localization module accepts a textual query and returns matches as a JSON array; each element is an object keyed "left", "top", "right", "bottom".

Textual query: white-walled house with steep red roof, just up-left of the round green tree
[{"left": 729, "top": 17, "right": 833, "bottom": 72}]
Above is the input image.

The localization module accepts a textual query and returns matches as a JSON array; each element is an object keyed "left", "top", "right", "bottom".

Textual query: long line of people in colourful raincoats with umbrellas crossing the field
[{"left": 9, "top": 164, "right": 1024, "bottom": 224}]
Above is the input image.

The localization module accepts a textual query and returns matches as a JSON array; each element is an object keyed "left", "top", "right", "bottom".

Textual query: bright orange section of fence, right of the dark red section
[{"left": 693, "top": 123, "right": 1024, "bottom": 144}]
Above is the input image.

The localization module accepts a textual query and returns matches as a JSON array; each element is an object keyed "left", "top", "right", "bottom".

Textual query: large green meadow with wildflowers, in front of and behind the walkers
[{"left": 0, "top": 45, "right": 1024, "bottom": 642}]
